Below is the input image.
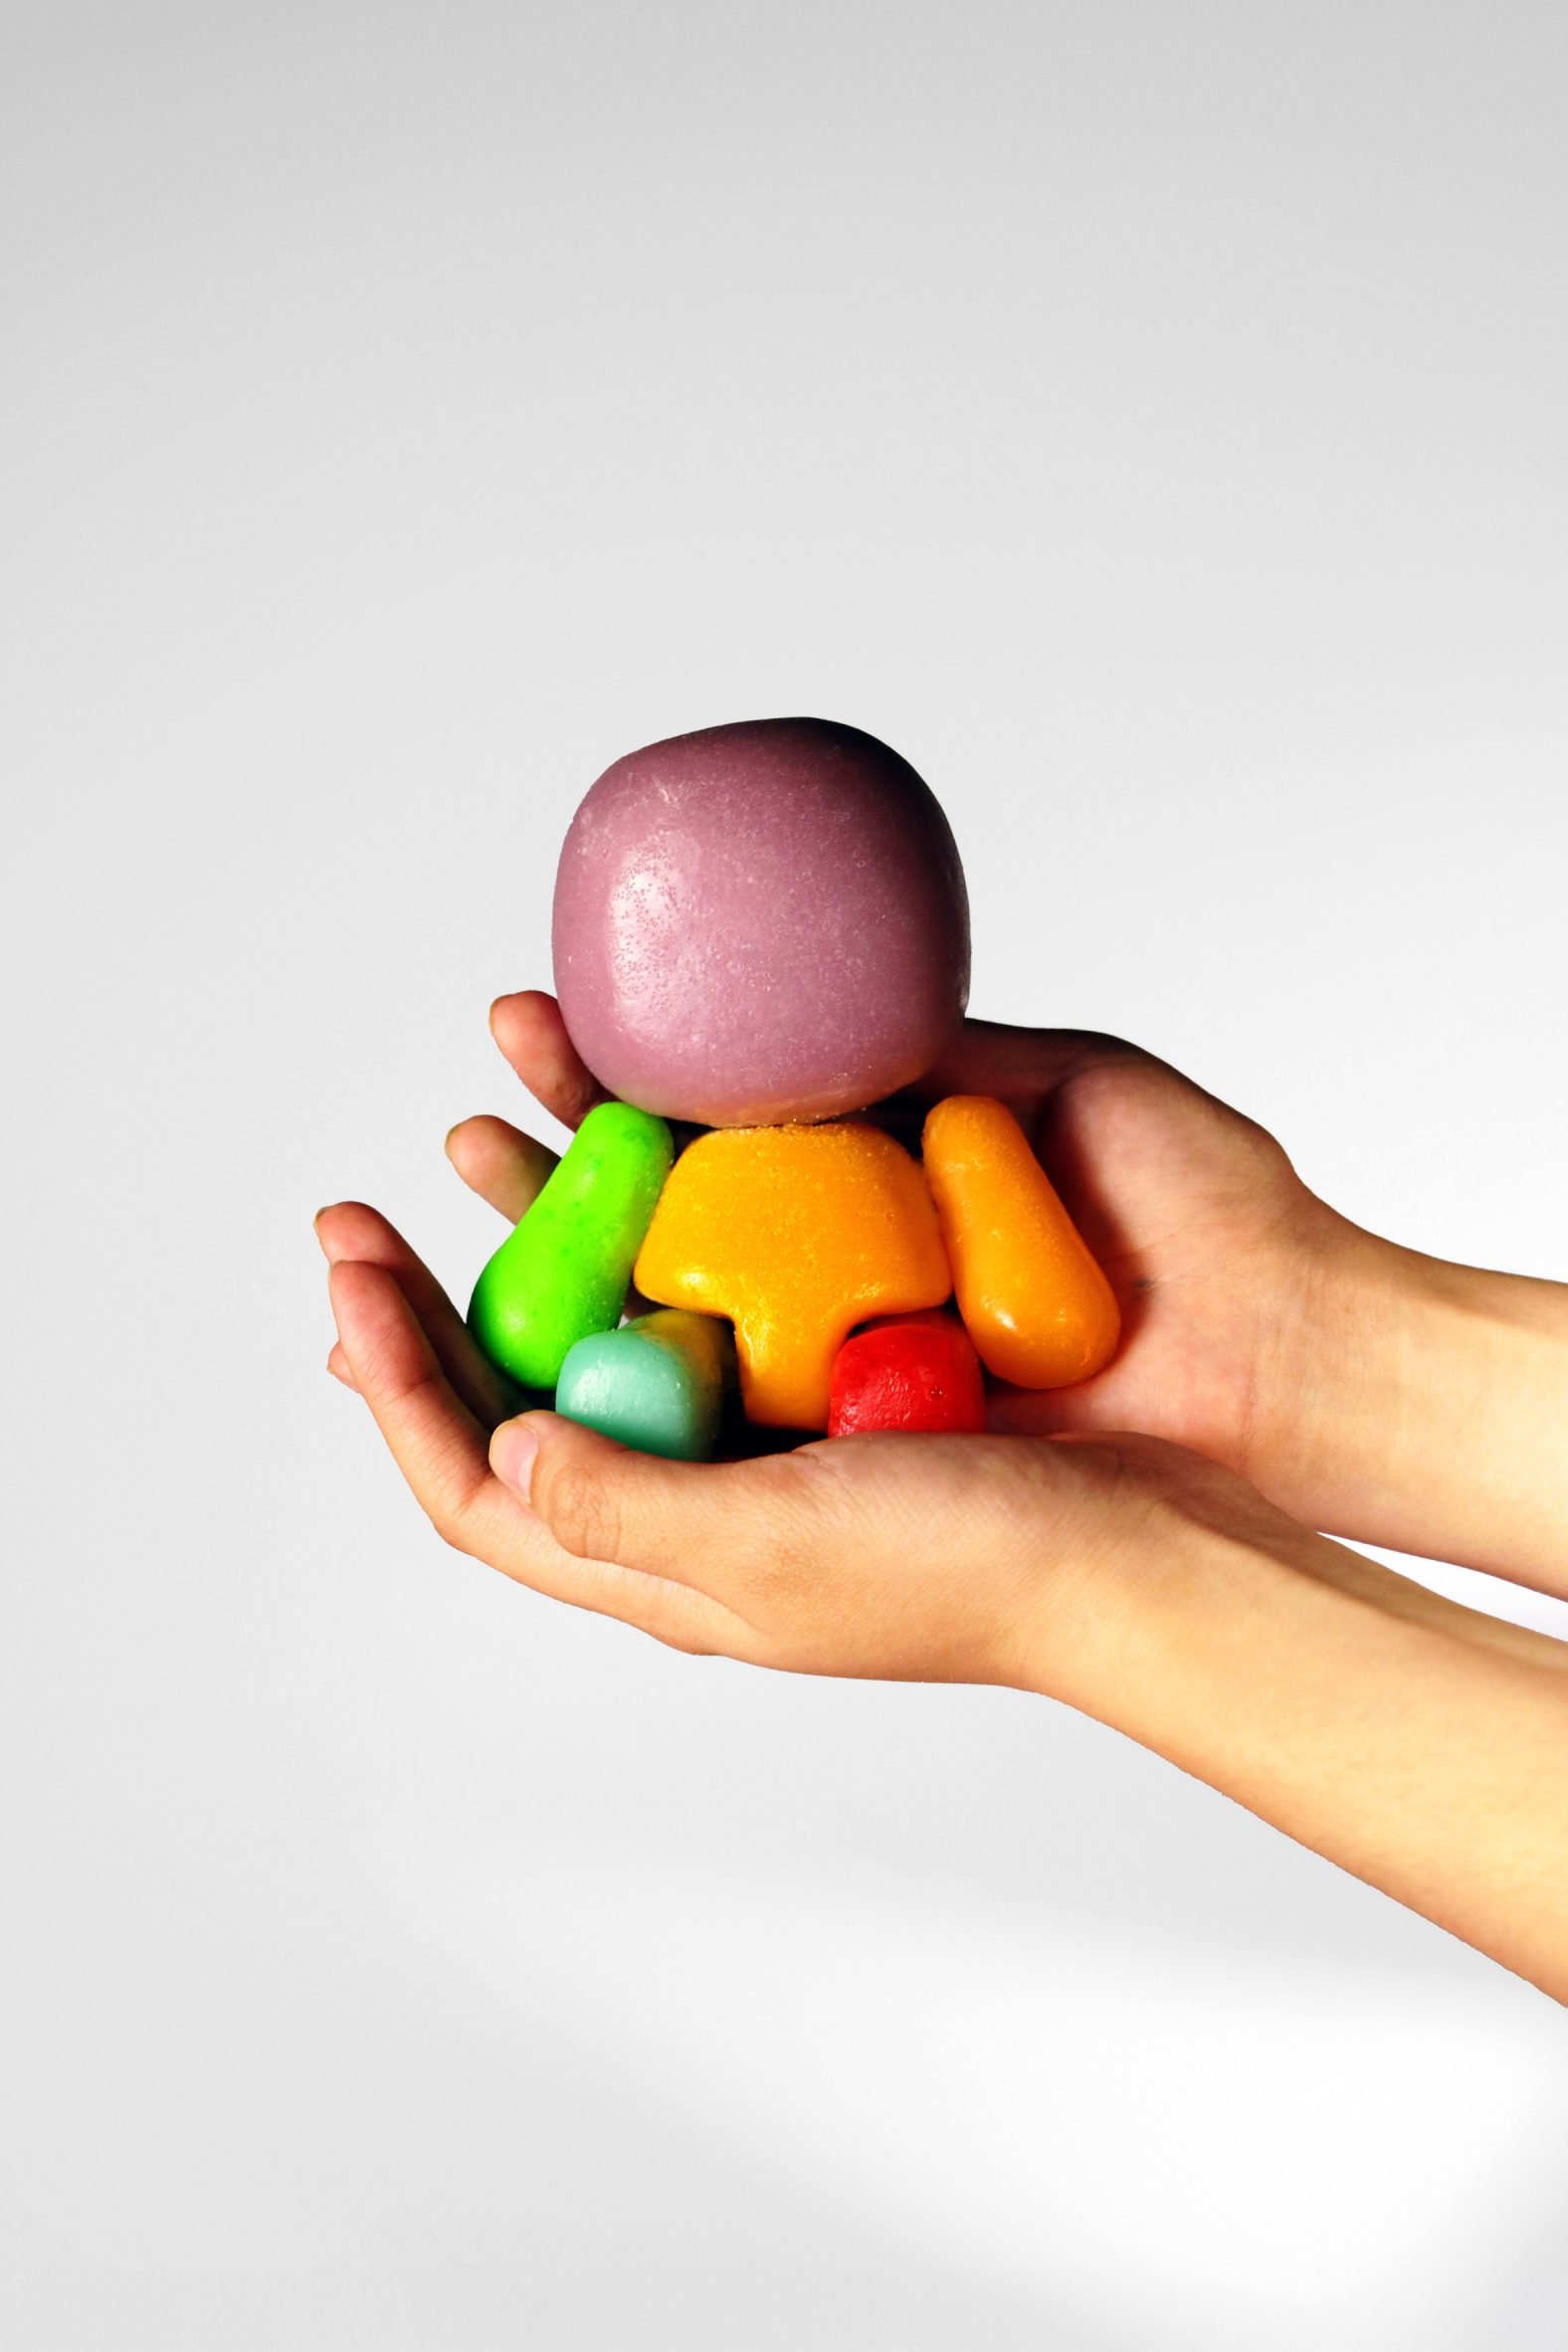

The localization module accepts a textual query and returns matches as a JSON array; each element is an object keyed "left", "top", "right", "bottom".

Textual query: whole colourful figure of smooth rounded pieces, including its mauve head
[{"left": 468, "top": 719, "right": 1119, "bottom": 1461}]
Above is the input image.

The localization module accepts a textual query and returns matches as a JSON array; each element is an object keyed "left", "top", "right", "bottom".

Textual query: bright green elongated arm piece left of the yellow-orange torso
[{"left": 468, "top": 1103, "right": 675, "bottom": 1388}]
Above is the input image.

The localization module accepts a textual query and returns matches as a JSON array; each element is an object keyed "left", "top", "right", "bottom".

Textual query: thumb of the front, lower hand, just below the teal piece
[{"left": 489, "top": 1414, "right": 806, "bottom": 1604}]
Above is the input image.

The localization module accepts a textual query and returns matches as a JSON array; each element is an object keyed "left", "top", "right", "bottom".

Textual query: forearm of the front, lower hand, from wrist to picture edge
[{"left": 1035, "top": 1531, "right": 1568, "bottom": 1999}]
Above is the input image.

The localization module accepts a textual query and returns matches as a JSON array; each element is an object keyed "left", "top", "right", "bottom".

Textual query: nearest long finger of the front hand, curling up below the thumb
[{"left": 329, "top": 1259, "right": 747, "bottom": 1652}]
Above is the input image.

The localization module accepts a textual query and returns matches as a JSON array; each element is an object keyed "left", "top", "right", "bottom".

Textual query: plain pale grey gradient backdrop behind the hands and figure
[{"left": 0, "top": 0, "right": 1568, "bottom": 2352}]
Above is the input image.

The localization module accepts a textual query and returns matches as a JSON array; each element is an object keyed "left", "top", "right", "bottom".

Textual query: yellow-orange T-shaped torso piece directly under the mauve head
[{"left": 633, "top": 1122, "right": 952, "bottom": 1430}]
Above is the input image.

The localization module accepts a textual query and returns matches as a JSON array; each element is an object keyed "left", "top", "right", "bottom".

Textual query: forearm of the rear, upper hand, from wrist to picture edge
[{"left": 1256, "top": 1228, "right": 1568, "bottom": 1595}]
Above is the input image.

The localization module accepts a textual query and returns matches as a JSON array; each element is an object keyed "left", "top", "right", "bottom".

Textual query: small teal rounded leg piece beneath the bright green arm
[{"left": 555, "top": 1307, "right": 736, "bottom": 1463}]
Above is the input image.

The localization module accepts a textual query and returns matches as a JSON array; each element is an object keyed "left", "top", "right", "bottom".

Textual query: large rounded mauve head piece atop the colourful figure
[{"left": 555, "top": 719, "right": 968, "bottom": 1126}]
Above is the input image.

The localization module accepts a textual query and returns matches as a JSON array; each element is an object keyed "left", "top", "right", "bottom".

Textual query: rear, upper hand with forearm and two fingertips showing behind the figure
[{"left": 447, "top": 990, "right": 1568, "bottom": 1590}]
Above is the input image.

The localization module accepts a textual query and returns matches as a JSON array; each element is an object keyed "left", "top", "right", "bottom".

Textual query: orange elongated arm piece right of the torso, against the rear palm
[{"left": 924, "top": 1093, "right": 1121, "bottom": 1388}]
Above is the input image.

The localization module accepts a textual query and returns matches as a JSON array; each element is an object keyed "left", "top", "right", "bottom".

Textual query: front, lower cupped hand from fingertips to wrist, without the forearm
[{"left": 317, "top": 1202, "right": 1297, "bottom": 1705}]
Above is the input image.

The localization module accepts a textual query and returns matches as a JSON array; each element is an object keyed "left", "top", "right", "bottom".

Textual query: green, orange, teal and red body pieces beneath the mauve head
[{"left": 471, "top": 1093, "right": 1116, "bottom": 1461}]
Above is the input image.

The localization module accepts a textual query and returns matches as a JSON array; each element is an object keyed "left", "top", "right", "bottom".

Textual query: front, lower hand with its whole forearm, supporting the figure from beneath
[{"left": 317, "top": 1204, "right": 1568, "bottom": 1997}]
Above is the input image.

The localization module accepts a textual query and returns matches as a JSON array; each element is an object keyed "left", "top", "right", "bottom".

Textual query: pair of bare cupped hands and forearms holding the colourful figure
[{"left": 317, "top": 990, "right": 1568, "bottom": 1999}]
